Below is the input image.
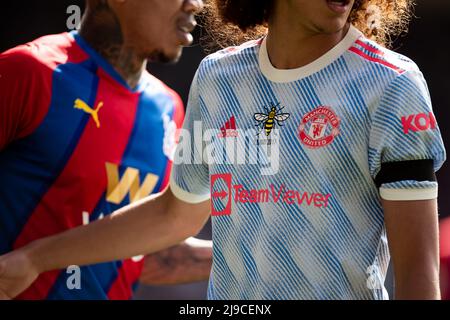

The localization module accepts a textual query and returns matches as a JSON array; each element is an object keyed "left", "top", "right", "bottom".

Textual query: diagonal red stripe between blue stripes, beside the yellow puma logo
[{"left": 14, "top": 70, "right": 139, "bottom": 299}]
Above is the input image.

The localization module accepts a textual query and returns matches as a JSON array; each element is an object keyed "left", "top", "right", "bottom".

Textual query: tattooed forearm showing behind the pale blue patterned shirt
[{"left": 140, "top": 238, "right": 212, "bottom": 286}]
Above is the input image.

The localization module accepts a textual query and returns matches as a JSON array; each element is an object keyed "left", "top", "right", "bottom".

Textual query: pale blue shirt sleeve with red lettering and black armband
[{"left": 369, "top": 70, "right": 446, "bottom": 201}]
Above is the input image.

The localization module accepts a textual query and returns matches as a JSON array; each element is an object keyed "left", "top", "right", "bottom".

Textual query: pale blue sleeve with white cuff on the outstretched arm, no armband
[{"left": 170, "top": 72, "right": 210, "bottom": 203}]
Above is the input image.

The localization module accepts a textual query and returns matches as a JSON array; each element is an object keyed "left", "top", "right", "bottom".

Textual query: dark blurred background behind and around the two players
[{"left": 0, "top": 0, "right": 450, "bottom": 299}]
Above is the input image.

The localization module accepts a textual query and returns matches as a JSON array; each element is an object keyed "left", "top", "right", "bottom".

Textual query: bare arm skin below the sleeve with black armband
[{"left": 383, "top": 199, "right": 440, "bottom": 299}]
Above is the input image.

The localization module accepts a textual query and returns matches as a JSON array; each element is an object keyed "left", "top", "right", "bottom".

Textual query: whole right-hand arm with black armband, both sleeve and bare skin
[{"left": 369, "top": 70, "right": 446, "bottom": 298}]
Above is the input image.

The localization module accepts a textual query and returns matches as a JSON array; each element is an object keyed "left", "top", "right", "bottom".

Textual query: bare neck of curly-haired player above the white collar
[{"left": 267, "top": 19, "right": 350, "bottom": 69}]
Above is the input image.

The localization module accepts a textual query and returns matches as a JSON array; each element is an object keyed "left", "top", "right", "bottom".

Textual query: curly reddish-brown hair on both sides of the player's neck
[{"left": 202, "top": 0, "right": 414, "bottom": 49}]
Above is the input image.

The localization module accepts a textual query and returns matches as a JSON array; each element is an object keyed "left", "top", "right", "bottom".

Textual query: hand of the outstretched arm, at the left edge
[{"left": 0, "top": 249, "right": 39, "bottom": 300}]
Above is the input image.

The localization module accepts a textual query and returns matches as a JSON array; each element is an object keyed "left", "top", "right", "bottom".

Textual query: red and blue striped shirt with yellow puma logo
[{"left": 0, "top": 33, "right": 184, "bottom": 299}]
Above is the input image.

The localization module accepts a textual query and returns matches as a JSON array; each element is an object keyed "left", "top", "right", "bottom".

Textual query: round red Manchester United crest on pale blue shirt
[{"left": 298, "top": 106, "right": 341, "bottom": 149}]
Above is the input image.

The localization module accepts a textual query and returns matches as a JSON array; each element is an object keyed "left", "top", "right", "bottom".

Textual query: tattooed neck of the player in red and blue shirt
[{"left": 79, "top": 14, "right": 147, "bottom": 88}]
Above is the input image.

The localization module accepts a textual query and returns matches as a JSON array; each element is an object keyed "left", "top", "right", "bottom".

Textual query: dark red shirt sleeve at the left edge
[{"left": 0, "top": 46, "right": 51, "bottom": 151}]
